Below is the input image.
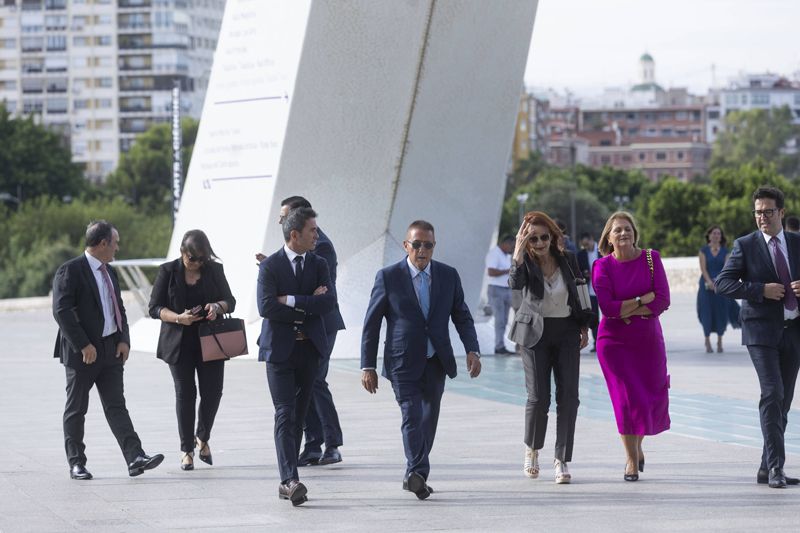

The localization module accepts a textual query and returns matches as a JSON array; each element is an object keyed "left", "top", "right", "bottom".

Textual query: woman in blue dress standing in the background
[{"left": 697, "top": 226, "right": 735, "bottom": 353}]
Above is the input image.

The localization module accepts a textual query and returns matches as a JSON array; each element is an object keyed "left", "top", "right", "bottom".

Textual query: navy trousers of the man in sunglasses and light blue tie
[{"left": 392, "top": 355, "right": 446, "bottom": 479}]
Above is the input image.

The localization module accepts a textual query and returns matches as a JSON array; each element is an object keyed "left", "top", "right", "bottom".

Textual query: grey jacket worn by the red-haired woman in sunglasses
[{"left": 508, "top": 252, "right": 588, "bottom": 348}]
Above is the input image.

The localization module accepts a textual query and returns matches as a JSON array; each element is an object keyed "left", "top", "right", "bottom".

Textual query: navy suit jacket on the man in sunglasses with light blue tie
[{"left": 361, "top": 259, "right": 480, "bottom": 381}]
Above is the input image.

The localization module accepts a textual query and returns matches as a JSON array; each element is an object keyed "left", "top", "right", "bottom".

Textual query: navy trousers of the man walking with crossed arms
[{"left": 267, "top": 340, "right": 320, "bottom": 483}]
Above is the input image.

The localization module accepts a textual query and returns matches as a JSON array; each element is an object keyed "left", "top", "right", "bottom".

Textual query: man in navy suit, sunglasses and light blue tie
[{"left": 361, "top": 220, "right": 481, "bottom": 500}]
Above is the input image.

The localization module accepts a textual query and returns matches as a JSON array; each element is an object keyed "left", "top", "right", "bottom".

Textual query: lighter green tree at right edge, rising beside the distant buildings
[{"left": 711, "top": 106, "right": 800, "bottom": 177}]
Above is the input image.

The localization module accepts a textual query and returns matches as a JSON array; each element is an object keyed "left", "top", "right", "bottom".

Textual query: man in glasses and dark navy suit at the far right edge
[{"left": 715, "top": 187, "right": 800, "bottom": 488}]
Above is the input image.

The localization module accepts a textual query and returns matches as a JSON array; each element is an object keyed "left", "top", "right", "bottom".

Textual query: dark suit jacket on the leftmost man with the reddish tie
[{"left": 53, "top": 254, "right": 131, "bottom": 369}]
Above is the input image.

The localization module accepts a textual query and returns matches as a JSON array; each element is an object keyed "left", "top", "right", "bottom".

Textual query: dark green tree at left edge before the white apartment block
[{"left": 0, "top": 104, "right": 87, "bottom": 200}]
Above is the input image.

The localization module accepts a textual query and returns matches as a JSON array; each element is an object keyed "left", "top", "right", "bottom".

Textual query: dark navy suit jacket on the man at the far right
[{"left": 714, "top": 230, "right": 800, "bottom": 347}]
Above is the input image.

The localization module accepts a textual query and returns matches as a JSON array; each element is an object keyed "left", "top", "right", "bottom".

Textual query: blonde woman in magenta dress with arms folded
[{"left": 592, "top": 211, "right": 670, "bottom": 481}]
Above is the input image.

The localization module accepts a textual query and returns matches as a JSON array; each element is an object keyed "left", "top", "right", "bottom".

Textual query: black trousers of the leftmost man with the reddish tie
[{"left": 64, "top": 334, "right": 144, "bottom": 467}]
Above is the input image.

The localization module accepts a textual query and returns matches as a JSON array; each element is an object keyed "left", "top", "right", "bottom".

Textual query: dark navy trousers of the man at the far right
[{"left": 747, "top": 320, "right": 800, "bottom": 469}]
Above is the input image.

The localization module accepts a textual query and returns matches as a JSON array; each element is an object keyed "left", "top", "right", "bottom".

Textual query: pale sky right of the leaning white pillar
[{"left": 525, "top": 0, "right": 800, "bottom": 97}]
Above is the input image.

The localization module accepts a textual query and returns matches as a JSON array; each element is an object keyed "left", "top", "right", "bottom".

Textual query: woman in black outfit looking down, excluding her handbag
[{"left": 150, "top": 230, "right": 236, "bottom": 470}]
